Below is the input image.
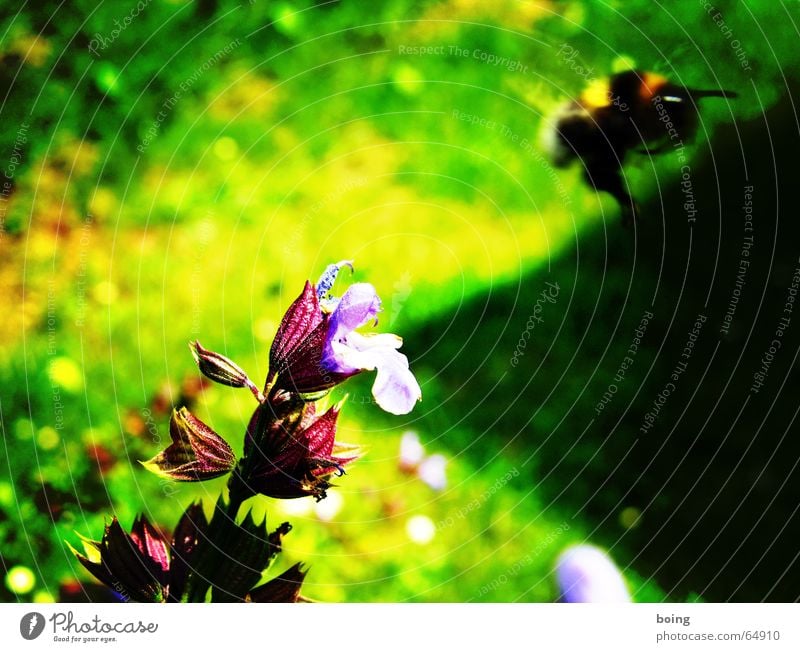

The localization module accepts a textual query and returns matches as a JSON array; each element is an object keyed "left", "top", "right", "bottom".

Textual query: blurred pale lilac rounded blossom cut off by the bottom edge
[{"left": 556, "top": 545, "right": 631, "bottom": 602}]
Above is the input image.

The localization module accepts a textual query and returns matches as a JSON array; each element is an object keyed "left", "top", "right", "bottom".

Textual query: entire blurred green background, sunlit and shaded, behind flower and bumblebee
[{"left": 0, "top": 0, "right": 800, "bottom": 602}]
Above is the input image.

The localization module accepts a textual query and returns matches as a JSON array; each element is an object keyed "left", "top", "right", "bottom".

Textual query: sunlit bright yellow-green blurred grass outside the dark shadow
[{"left": 0, "top": 0, "right": 797, "bottom": 601}]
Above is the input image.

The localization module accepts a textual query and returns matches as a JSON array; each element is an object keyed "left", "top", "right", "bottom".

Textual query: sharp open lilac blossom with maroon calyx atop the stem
[{"left": 267, "top": 261, "right": 422, "bottom": 414}]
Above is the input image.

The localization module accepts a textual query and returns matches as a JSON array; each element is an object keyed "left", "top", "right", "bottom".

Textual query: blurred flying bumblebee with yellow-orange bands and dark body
[{"left": 545, "top": 70, "right": 737, "bottom": 225}]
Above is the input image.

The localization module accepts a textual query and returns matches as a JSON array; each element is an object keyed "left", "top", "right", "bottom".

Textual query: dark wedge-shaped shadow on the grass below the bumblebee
[{"left": 358, "top": 79, "right": 800, "bottom": 601}]
